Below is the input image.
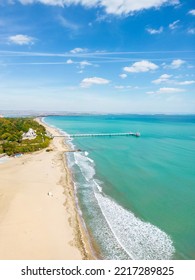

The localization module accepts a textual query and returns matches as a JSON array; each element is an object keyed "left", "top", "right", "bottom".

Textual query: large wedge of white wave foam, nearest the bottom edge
[{"left": 95, "top": 192, "right": 175, "bottom": 260}]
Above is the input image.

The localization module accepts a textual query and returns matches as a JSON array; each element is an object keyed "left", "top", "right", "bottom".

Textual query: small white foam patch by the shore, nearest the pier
[{"left": 74, "top": 153, "right": 95, "bottom": 182}]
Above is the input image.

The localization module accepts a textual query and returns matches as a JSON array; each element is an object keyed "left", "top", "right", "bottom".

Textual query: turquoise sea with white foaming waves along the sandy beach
[{"left": 45, "top": 115, "right": 195, "bottom": 259}]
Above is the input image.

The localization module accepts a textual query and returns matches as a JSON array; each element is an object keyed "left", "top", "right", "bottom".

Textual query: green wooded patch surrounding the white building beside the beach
[{"left": 0, "top": 118, "right": 50, "bottom": 156}]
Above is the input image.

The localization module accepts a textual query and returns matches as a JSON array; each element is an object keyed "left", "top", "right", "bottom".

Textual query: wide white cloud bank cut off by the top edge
[{"left": 16, "top": 0, "right": 179, "bottom": 15}]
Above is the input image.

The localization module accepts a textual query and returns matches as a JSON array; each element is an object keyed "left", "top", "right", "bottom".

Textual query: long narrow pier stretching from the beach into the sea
[{"left": 52, "top": 132, "right": 140, "bottom": 138}]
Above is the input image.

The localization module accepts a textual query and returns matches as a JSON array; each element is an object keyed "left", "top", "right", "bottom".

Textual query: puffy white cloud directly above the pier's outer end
[{"left": 123, "top": 60, "right": 158, "bottom": 73}]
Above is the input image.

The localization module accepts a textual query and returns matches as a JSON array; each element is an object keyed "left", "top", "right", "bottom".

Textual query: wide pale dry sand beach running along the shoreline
[{"left": 0, "top": 117, "right": 92, "bottom": 260}]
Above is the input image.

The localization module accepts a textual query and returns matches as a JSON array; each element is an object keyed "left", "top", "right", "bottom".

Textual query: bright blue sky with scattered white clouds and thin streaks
[{"left": 0, "top": 0, "right": 195, "bottom": 114}]
